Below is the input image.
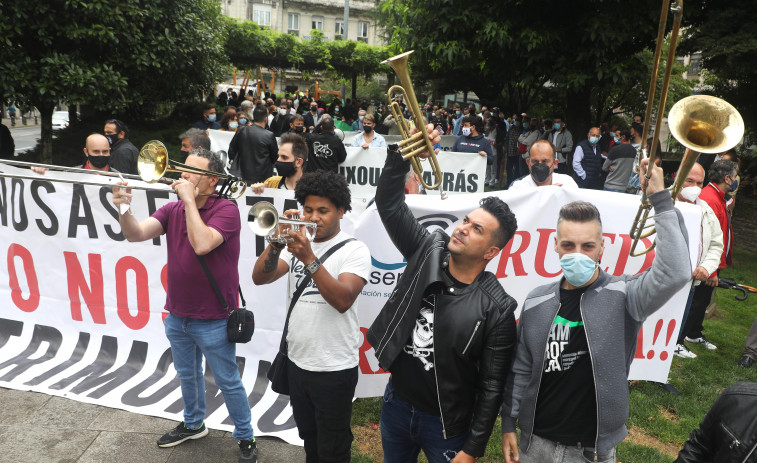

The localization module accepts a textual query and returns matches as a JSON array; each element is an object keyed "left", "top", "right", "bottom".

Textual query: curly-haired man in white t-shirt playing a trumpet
[{"left": 252, "top": 170, "right": 371, "bottom": 462}]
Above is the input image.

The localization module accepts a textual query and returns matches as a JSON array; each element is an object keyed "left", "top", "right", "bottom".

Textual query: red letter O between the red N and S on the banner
[{"left": 116, "top": 256, "right": 150, "bottom": 330}]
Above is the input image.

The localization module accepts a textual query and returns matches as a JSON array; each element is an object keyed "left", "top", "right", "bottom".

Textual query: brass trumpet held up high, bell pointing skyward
[{"left": 381, "top": 50, "right": 447, "bottom": 199}]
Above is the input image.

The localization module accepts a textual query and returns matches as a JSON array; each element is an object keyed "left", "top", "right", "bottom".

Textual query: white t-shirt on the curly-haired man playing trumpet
[{"left": 279, "top": 231, "right": 371, "bottom": 371}]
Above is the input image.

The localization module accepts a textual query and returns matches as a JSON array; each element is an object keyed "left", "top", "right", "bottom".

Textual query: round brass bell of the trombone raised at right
[{"left": 668, "top": 95, "right": 744, "bottom": 153}]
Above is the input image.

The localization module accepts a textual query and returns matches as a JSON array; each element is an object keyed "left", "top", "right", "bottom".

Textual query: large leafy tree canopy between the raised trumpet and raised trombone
[{"left": 381, "top": 0, "right": 680, "bottom": 133}]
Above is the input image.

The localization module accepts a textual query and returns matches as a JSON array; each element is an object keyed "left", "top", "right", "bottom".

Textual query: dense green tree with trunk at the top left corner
[{"left": 0, "top": 0, "right": 225, "bottom": 163}]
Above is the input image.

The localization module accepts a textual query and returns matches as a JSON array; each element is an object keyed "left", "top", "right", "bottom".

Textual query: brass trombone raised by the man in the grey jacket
[{"left": 629, "top": 0, "right": 744, "bottom": 257}]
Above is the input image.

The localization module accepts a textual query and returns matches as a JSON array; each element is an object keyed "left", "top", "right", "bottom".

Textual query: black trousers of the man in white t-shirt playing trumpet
[{"left": 287, "top": 360, "right": 358, "bottom": 463}]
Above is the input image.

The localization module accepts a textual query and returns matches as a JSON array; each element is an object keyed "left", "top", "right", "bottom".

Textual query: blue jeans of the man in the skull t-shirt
[{"left": 381, "top": 380, "right": 468, "bottom": 463}]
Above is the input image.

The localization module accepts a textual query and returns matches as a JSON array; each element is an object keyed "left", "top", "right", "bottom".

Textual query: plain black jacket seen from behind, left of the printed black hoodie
[{"left": 229, "top": 124, "right": 279, "bottom": 183}]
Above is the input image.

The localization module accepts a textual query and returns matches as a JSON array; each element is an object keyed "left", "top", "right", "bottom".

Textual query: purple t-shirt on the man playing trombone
[{"left": 152, "top": 198, "right": 241, "bottom": 319}]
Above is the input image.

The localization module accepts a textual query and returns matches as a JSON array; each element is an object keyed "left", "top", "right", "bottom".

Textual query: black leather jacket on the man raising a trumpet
[{"left": 367, "top": 145, "right": 517, "bottom": 457}]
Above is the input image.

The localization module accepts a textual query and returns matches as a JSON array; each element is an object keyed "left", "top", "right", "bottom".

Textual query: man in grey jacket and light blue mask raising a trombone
[{"left": 502, "top": 160, "right": 692, "bottom": 463}]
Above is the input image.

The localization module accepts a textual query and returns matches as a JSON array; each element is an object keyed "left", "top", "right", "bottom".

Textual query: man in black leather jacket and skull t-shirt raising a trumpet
[{"left": 367, "top": 145, "right": 517, "bottom": 463}]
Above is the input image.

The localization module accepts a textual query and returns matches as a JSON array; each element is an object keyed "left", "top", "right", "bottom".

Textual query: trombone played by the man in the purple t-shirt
[{"left": 0, "top": 140, "right": 247, "bottom": 199}]
